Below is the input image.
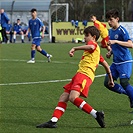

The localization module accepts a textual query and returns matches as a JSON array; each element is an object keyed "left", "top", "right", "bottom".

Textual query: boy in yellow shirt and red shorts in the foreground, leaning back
[{"left": 36, "top": 26, "right": 114, "bottom": 128}]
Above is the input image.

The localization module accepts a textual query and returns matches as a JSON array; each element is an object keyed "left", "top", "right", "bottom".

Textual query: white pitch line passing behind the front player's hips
[{"left": 0, "top": 74, "right": 106, "bottom": 86}]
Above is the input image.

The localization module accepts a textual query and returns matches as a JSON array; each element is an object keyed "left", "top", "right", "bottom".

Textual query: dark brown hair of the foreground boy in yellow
[{"left": 84, "top": 26, "right": 100, "bottom": 41}]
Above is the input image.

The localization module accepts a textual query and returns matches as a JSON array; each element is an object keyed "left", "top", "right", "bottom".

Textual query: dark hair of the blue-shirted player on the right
[{"left": 106, "top": 9, "right": 119, "bottom": 19}]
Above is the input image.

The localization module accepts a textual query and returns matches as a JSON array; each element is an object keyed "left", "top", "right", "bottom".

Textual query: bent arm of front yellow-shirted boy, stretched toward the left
[{"left": 69, "top": 44, "right": 95, "bottom": 57}]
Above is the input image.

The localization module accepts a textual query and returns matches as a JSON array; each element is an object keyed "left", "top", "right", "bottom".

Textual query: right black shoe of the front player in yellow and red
[{"left": 96, "top": 111, "right": 105, "bottom": 128}]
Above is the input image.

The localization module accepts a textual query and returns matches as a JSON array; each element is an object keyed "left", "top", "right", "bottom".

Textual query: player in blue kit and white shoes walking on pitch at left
[{"left": 26, "top": 8, "right": 52, "bottom": 63}]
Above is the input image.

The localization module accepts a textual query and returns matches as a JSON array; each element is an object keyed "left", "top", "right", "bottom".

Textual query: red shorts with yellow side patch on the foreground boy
[{"left": 63, "top": 73, "right": 92, "bottom": 97}]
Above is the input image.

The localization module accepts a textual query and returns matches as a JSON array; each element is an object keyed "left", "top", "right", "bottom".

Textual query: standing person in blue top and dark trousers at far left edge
[{"left": 0, "top": 9, "right": 9, "bottom": 43}]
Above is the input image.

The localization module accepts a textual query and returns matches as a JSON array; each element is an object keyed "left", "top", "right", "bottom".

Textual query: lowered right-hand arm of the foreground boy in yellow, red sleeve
[{"left": 99, "top": 56, "right": 114, "bottom": 87}]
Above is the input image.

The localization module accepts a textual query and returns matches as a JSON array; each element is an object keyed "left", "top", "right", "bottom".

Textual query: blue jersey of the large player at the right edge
[{"left": 109, "top": 25, "right": 133, "bottom": 64}]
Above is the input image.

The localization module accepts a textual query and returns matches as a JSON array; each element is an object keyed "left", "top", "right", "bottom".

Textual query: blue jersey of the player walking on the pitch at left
[{"left": 29, "top": 18, "right": 43, "bottom": 39}]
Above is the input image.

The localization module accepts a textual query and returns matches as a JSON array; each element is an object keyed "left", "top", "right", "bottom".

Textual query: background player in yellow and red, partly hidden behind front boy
[{"left": 90, "top": 15, "right": 111, "bottom": 51}]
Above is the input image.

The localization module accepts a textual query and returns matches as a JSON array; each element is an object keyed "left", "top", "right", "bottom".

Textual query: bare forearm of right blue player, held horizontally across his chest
[{"left": 108, "top": 40, "right": 133, "bottom": 48}]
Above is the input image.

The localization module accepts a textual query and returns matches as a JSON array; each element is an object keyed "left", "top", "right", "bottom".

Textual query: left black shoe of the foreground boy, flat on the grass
[{"left": 36, "top": 120, "right": 57, "bottom": 128}]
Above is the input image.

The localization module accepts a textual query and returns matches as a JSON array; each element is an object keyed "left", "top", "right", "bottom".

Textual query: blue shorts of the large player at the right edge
[{"left": 110, "top": 62, "right": 132, "bottom": 80}]
